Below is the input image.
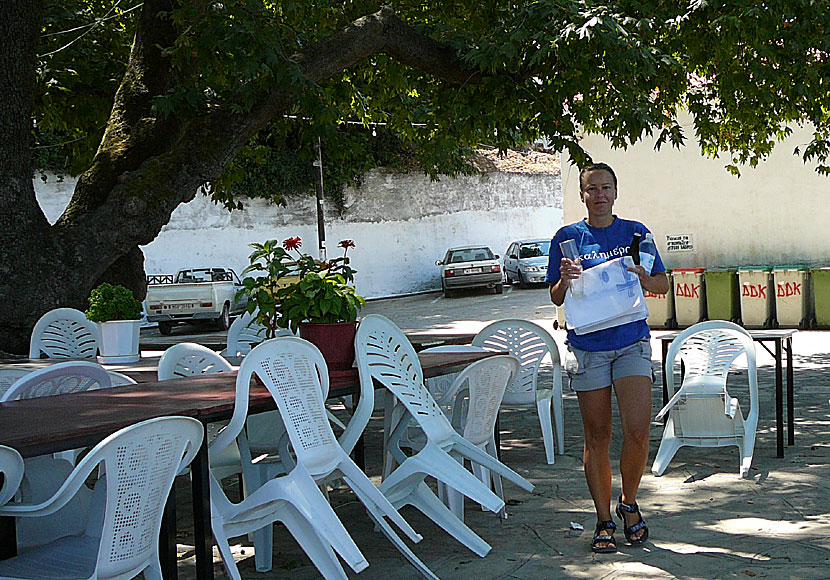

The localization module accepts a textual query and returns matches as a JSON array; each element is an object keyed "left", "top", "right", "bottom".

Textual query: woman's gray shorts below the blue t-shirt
[{"left": 565, "top": 338, "right": 654, "bottom": 391}]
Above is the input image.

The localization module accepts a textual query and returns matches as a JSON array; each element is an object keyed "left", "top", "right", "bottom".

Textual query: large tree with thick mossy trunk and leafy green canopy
[{"left": 0, "top": 0, "right": 830, "bottom": 351}]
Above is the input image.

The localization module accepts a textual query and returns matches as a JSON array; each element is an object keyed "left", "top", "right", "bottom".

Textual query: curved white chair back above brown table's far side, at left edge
[{"left": 0, "top": 361, "right": 112, "bottom": 402}]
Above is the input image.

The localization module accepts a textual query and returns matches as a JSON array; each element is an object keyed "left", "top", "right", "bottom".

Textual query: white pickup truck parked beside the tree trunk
[{"left": 145, "top": 268, "right": 248, "bottom": 335}]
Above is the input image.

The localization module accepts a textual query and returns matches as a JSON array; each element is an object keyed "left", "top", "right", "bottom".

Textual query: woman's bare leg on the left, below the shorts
[{"left": 576, "top": 386, "right": 611, "bottom": 535}]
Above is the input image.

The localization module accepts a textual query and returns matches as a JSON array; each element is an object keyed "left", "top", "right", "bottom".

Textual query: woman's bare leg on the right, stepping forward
[{"left": 614, "top": 376, "right": 651, "bottom": 538}]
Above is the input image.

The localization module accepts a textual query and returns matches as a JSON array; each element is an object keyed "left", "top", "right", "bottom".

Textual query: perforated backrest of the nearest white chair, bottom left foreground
[{"left": 81, "top": 417, "right": 204, "bottom": 577}]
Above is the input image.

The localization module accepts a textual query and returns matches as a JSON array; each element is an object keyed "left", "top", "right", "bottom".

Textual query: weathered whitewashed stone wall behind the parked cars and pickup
[{"left": 35, "top": 171, "right": 563, "bottom": 298}]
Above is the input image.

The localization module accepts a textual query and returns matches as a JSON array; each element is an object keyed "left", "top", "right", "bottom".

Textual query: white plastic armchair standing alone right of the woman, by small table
[{"left": 651, "top": 320, "right": 758, "bottom": 477}]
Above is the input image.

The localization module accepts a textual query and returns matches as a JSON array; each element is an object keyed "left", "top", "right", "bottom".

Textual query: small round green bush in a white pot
[{"left": 85, "top": 282, "right": 141, "bottom": 363}]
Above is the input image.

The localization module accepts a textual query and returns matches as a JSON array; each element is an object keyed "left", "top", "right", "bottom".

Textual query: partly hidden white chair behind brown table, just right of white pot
[{"left": 158, "top": 342, "right": 242, "bottom": 480}]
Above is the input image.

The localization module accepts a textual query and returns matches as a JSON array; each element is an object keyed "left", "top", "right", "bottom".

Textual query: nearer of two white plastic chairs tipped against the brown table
[{"left": 211, "top": 338, "right": 436, "bottom": 579}]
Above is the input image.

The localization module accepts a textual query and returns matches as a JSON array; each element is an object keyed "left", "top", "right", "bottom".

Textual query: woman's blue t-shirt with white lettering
[{"left": 545, "top": 216, "right": 666, "bottom": 351}]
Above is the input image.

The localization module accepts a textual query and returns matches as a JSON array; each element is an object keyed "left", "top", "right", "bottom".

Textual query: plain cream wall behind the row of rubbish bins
[{"left": 562, "top": 114, "right": 830, "bottom": 268}]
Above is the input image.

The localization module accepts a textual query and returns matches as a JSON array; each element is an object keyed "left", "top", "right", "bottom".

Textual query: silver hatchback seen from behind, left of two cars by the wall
[{"left": 435, "top": 246, "right": 504, "bottom": 297}]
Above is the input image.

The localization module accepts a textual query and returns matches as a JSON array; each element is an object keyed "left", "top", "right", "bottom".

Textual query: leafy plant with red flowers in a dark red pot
[{"left": 234, "top": 237, "right": 366, "bottom": 369}]
